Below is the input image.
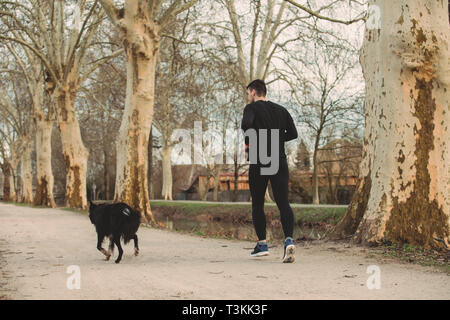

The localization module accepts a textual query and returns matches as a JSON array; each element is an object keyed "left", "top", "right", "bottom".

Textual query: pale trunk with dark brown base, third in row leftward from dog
[{"left": 33, "top": 118, "right": 56, "bottom": 208}]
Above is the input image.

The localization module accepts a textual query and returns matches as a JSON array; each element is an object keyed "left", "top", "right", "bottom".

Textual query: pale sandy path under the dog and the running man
[{"left": 0, "top": 203, "right": 450, "bottom": 299}]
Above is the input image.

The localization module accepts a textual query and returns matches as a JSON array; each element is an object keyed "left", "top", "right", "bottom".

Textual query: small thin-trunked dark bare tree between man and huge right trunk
[{"left": 287, "top": 44, "right": 363, "bottom": 204}]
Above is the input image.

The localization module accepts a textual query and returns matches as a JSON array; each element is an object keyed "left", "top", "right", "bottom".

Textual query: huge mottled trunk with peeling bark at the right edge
[{"left": 330, "top": 0, "right": 450, "bottom": 248}]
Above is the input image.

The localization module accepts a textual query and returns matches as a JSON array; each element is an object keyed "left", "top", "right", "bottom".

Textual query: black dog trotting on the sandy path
[{"left": 89, "top": 201, "right": 141, "bottom": 263}]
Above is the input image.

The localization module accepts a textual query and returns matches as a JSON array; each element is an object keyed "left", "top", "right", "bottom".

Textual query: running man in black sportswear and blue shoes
[{"left": 241, "top": 80, "right": 298, "bottom": 263}]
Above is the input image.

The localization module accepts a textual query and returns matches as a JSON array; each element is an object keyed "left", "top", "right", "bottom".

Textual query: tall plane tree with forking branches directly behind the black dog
[{"left": 100, "top": 0, "right": 198, "bottom": 220}]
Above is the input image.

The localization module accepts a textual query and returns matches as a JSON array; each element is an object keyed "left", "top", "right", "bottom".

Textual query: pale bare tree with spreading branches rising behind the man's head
[{"left": 198, "top": 0, "right": 306, "bottom": 201}]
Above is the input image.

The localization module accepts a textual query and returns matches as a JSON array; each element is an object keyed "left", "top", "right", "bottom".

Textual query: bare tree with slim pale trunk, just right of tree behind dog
[{"left": 154, "top": 9, "right": 210, "bottom": 200}]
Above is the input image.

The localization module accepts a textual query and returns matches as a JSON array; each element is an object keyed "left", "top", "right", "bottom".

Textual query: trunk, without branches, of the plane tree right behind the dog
[{"left": 114, "top": 25, "right": 159, "bottom": 221}]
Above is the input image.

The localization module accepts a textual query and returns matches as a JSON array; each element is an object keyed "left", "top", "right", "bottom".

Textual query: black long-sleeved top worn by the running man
[{"left": 241, "top": 100, "right": 298, "bottom": 163}]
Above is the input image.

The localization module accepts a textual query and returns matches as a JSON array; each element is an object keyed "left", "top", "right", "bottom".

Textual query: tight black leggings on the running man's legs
[{"left": 248, "top": 157, "right": 294, "bottom": 240}]
